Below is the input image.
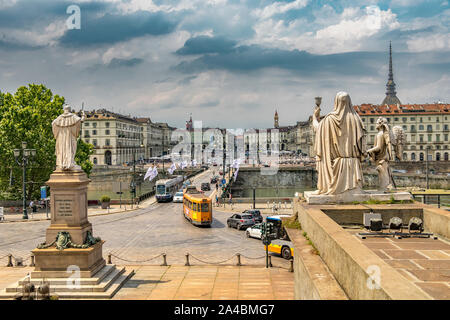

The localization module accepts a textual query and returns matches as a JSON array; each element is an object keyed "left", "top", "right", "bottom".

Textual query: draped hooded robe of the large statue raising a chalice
[{"left": 314, "top": 94, "right": 364, "bottom": 195}]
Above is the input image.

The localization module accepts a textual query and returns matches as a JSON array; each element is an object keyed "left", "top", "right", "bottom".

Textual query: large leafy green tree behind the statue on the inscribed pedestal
[{"left": 0, "top": 84, "right": 92, "bottom": 199}]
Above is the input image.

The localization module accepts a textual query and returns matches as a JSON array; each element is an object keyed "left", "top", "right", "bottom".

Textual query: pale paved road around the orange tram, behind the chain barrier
[{"left": 0, "top": 167, "right": 287, "bottom": 266}]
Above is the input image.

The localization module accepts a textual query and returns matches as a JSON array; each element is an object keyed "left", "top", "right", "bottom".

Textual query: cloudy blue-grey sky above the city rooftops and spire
[{"left": 0, "top": 0, "right": 450, "bottom": 128}]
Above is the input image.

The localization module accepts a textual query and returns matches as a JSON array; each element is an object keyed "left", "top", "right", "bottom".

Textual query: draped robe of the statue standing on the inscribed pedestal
[{"left": 52, "top": 113, "right": 81, "bottom": 170}]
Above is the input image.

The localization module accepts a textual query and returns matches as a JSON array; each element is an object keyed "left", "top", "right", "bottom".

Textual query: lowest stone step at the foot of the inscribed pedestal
[{"left": 0, "top": 268, "right": 134, "bottom": 300}]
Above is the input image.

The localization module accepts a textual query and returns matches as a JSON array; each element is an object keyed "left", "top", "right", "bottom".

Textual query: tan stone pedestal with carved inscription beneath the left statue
[{"left": 31, "top": 170, "right": 106, "bottom": 278}]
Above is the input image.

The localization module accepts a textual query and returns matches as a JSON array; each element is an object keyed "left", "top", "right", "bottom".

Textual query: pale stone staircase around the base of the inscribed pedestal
[{"left": 0, "top": 264, "right": 134, "bottom": 300}]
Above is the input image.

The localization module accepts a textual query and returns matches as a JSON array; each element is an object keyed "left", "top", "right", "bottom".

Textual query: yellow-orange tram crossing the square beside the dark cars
[{"left": 183, "top": 186, "right": 212, "bottom": 226}]
